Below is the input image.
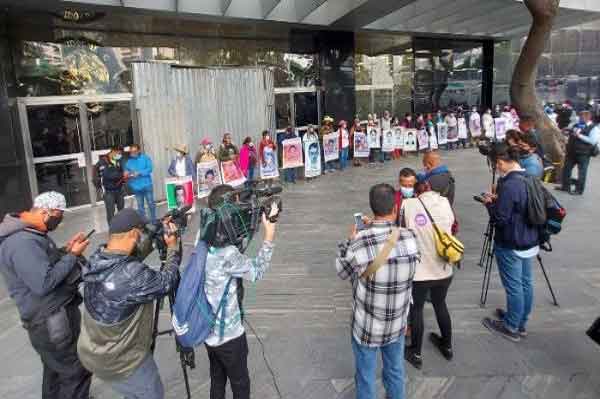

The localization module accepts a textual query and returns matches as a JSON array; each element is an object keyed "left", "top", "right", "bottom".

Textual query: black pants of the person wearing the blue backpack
[{"left": 206, "top": 334, "right": 250, "bottom": 399}]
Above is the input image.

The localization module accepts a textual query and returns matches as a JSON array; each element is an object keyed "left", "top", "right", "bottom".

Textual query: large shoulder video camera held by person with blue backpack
[{"left": 200, "top": 183, "right": 282, "bottom": 252}]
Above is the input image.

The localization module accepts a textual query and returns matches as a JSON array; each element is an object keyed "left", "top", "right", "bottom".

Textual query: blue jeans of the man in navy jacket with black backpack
[{"left": 494, "top": 246, "right": 533, "bottom": 332}]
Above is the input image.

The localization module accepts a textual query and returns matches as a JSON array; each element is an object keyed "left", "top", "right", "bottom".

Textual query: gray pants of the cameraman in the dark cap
[{"left": 110, "top": 353, "right": 165, "bottom": 399}]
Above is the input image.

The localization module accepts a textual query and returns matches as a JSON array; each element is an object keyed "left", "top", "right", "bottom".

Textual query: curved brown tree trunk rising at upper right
[{"left": 510, "top": 0, "right": 565, "bottom": 167}]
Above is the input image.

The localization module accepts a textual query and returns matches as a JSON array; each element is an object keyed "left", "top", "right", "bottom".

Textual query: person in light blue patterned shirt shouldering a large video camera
[{"left": 199, "top": 184, "right": 279, "bottom": 399}]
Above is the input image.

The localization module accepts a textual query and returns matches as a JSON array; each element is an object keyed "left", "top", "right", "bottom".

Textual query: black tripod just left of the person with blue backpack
[{"left": 150, "top": 241, "right": 196, "bottom": 399}]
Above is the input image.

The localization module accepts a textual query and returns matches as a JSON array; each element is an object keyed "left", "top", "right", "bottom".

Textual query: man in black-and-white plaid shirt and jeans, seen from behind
[{"left": 335, "top": 184, "right": 420, "bottom": 399}]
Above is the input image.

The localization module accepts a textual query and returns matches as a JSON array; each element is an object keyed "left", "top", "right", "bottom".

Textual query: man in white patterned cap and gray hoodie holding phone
[{"left": 0, "top": 191, "right": 92, "bottom": 399}]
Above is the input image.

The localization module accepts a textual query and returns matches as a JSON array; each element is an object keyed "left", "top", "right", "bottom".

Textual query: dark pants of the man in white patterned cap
[{"left": 27, "top": 305, "right": 92, "bottom": 399}]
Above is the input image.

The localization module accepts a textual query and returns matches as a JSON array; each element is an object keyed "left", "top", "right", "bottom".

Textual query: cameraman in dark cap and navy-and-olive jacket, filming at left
[{"left": 77, "top": 209, "right": 181, "bottom": 399}]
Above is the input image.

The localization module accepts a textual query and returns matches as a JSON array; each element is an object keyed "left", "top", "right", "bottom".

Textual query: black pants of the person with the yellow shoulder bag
[{"left": 410, "top": 277, "right": 452, "bottom": 353}]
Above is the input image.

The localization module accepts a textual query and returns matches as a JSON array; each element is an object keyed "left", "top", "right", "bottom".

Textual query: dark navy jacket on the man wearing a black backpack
[{"left": 488, "top": 171, "right": 539, "bottom": 250}]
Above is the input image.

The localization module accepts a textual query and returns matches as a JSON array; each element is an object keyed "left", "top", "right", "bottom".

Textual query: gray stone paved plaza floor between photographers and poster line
[{"left": 0, "top": 149, "right": 600, "bottom": 399}]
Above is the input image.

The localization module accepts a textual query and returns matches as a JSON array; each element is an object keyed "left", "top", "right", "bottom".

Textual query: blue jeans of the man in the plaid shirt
[{"left": 352, "top": 335, "right": 404, "bottom": 399}]
